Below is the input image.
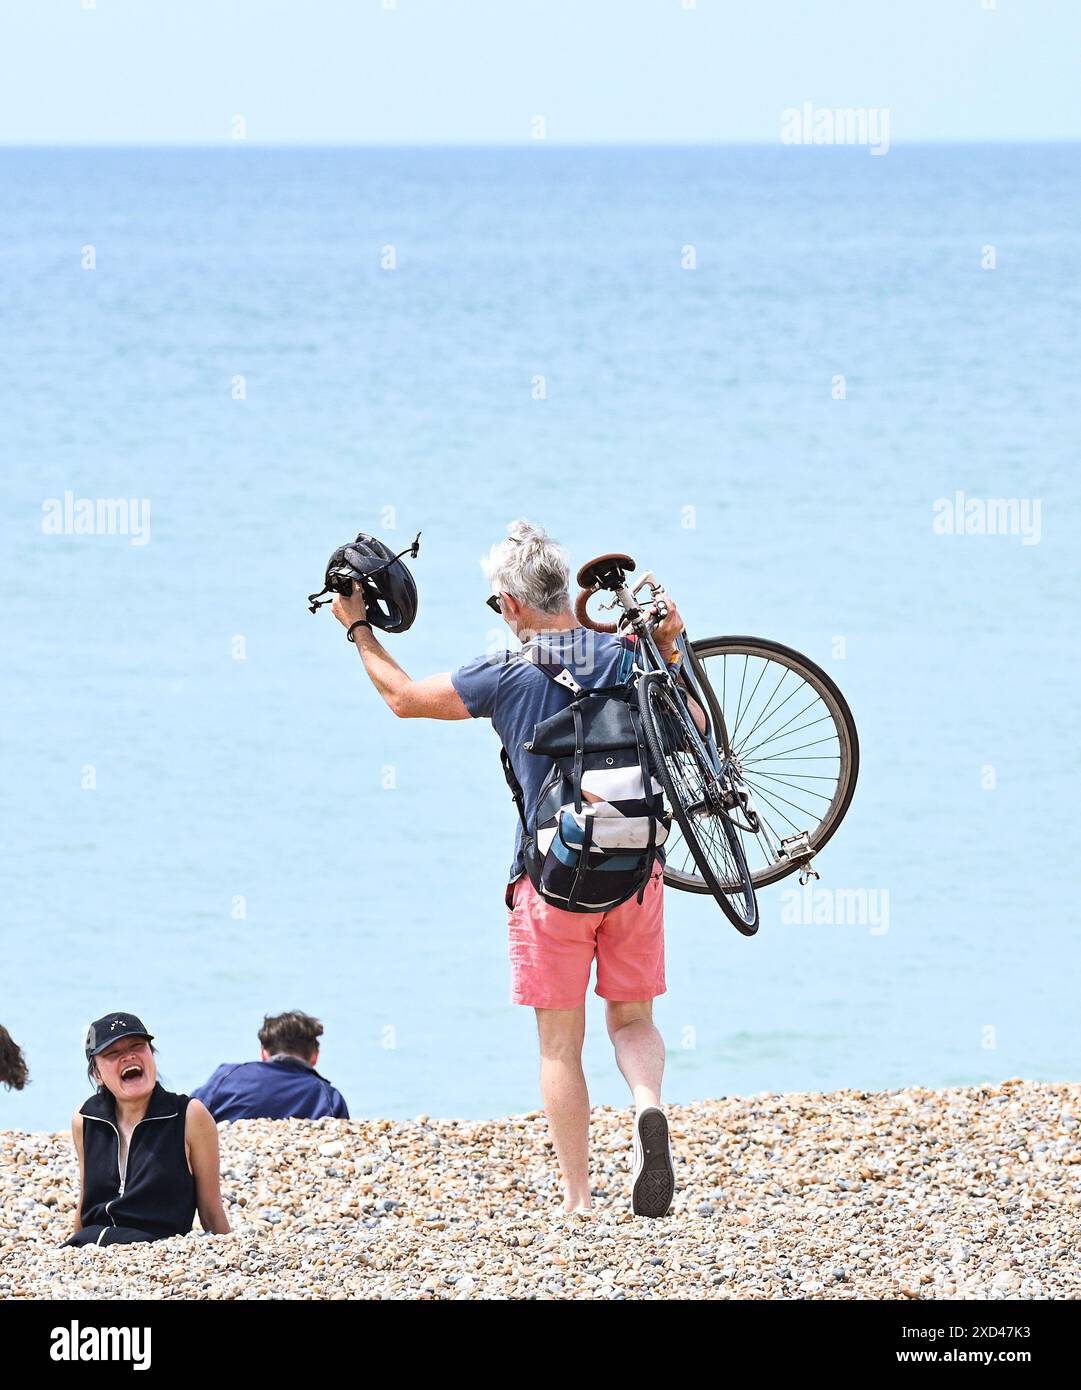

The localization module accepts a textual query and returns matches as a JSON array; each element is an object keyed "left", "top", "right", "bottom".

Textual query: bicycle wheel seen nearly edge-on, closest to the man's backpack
[{"left": 638, "top": 671, "right": 759, "bottom": 937}]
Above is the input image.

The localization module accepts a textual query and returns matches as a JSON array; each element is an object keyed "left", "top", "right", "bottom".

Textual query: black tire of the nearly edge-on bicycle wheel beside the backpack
[{"left": 638, "top": 671, "right": 760, "bottom": 937}]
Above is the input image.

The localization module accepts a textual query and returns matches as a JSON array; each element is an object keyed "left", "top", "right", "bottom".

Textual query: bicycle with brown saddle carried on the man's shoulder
[{"left": 575, "top": 553, "right": 860, "bottom": 937}]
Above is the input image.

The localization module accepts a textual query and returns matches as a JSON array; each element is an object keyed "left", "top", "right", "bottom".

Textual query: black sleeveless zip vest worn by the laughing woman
[{"left": 79, "top": 1081, "right": 196, "bottom": 1237}]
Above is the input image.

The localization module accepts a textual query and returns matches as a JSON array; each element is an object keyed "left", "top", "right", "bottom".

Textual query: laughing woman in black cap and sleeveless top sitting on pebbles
[{"left": 64, "top": 1013, "right": 229, "bottom": 1245}]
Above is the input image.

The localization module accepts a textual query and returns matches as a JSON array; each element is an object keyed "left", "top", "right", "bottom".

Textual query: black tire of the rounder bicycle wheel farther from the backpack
[{"left": 664, "top": 637, "right": 860, "bottom": 892}]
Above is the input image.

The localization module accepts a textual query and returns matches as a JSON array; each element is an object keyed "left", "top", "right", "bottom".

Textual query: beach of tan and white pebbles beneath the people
[{"left": 0, "top": 1080, "right": 1081, "bottom": 1300}]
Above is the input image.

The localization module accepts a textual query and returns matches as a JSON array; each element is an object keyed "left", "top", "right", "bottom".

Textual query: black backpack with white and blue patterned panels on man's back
[{"left": 500, "top": 648, "right": 671, "bottom": 912}]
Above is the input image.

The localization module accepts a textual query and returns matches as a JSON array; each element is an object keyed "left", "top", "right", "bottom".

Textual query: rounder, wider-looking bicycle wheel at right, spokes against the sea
[{"left": 664, "top": 637, "right": 860, "bottom": 892}]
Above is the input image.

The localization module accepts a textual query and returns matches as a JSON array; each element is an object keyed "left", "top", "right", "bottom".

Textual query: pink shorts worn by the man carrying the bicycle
[{"left": 507, "top": 865, "right": 664, "bottom": 1009}]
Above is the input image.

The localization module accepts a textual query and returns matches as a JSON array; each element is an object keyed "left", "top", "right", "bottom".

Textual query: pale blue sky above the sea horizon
[{"left": 0, "top": 0, "right": 1081, "bottom": 145}]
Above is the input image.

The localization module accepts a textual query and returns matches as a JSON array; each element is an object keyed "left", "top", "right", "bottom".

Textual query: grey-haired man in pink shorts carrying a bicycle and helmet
[{"left": 333, "top": 520, "right": 704, "bottom": 1216}]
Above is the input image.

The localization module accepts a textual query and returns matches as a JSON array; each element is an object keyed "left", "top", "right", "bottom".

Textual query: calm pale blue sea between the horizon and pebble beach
[{"left": 0, "top": 146, "right": 1081, "bottom": 1129}]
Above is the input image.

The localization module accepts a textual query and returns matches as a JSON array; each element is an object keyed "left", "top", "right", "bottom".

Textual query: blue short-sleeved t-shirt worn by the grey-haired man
[{"left": 450, "top": 627, "right": 635, "bottom": 883}]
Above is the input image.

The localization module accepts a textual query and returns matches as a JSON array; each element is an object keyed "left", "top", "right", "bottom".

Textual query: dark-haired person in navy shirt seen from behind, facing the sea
[{"left": 192, "top": 1011, "right": 349, "bottom": 1122}]
